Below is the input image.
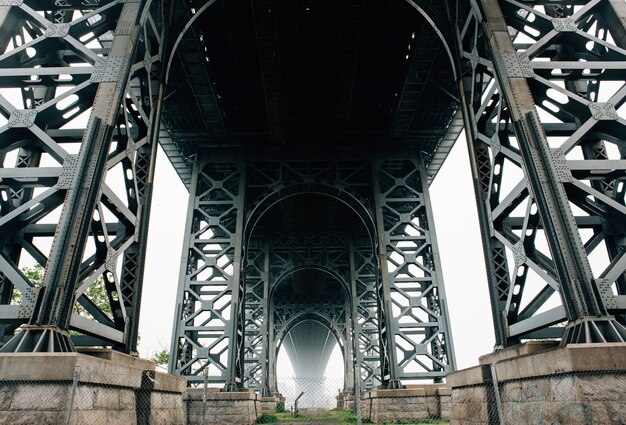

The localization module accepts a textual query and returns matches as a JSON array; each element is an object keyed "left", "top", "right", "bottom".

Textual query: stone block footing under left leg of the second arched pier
[{"left": 185, "top": 388, "right": 258, "bottom": 425}]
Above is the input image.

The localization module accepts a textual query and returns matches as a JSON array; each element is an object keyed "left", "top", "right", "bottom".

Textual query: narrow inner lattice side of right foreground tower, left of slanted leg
[{"left": 456, "top": 3, "right": 563, "bottom": 349}]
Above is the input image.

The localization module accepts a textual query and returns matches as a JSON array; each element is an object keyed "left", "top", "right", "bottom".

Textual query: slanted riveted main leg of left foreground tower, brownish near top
[{"left": 2, "top": 2, "right": 142, "bottom": 351}]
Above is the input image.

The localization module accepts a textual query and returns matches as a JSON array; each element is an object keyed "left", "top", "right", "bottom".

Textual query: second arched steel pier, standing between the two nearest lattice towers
[{"left": 171, "top": 159, "right": 454, "bottom": 393}]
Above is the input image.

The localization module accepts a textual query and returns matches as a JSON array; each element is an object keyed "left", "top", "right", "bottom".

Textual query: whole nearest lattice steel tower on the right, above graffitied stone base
[{"left": 457, "top": 0, "right": 626, "bottom": 347}]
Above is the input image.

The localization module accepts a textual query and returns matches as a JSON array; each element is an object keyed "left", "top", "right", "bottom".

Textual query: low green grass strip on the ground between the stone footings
[{"left": 257, "top": 410, "right": 449, "bottom": 425}]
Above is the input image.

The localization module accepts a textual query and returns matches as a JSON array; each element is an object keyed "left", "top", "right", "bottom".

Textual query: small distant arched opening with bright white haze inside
[{"left": 270, "top": 268, "right": 353, "bottom": 408}]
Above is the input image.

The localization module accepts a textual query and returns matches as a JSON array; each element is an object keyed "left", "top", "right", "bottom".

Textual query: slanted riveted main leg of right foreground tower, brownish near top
[{"left": 482, "top": 0, "right": 626, "bottom": 343}]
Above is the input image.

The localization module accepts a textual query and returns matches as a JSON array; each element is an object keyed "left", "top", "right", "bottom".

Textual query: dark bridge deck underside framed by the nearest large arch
[{"left": 163, "top": 0, "right": 461, "bottom": 182}]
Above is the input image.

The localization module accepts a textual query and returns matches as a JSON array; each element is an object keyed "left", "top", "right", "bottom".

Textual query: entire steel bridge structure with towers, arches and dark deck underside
[{"left": 0, "top": 0, "right": 626, "bottom": 393}]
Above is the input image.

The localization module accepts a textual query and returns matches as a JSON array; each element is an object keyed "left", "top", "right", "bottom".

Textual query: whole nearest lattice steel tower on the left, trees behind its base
[{"left": 0, "top": 0, "right": 167, "bottom": 352}]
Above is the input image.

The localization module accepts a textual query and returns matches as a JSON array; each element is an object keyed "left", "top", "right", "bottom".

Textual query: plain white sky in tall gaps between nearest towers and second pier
[{"left": 140, "top": 132, "right": 494, "bottom": 375}]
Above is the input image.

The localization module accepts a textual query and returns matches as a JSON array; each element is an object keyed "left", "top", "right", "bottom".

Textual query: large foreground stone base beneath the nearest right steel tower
[{"left": 447, "top": 343, "right": 626, "bottom": 425}]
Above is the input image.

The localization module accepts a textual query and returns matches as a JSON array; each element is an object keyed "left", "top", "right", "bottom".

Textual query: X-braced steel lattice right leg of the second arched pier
[{"left": 373, "top": 160, "right": 455, "bottom": 387}]
